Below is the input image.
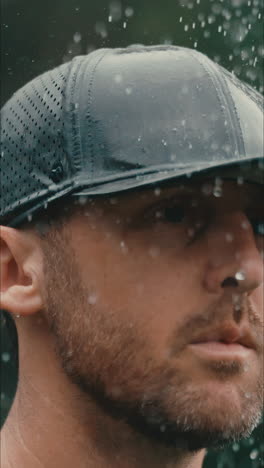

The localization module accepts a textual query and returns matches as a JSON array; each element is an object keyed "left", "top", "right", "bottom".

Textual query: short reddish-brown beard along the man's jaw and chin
[{"left": 40, "top": 229, "right": 262, "bottom": 452}]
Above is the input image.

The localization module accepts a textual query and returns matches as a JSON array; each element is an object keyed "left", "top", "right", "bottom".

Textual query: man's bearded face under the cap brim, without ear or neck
[{"left": 39, "top": 180, "right": 263, "bottom": 450}]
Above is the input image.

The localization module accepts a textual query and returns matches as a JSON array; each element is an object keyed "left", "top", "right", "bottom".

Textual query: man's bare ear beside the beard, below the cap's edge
[{"left": 0, "top": 226, "right": 43, "bottom": 316}]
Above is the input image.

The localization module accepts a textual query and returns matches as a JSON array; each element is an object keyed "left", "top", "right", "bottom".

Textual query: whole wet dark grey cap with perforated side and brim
[{"left": 0, "top": 45, "right": 264, "bottom": 226}]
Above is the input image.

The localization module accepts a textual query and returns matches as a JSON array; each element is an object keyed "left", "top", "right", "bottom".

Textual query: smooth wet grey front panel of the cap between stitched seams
[{"left": 81, "top": 47, "right": 235, "bottom": 183}]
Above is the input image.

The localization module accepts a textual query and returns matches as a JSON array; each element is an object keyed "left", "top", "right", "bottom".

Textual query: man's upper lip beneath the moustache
[{"left": 191, "top": 326, "right": 257, "bottom": 350}]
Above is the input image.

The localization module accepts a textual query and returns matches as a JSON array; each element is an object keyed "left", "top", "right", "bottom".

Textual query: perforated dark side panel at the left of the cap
[{"left": 0, "top": 64, "right": 71, "bottom": 223}]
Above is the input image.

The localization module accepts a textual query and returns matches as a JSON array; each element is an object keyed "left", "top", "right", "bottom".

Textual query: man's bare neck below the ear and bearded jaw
[{"left": 1, "top": 319, "right": 205, "bottom": 468}]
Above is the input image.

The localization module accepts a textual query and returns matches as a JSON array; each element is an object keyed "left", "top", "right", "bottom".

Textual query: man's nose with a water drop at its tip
[{"left": 204, "top": 211, "right": 263, "bottom": 295}]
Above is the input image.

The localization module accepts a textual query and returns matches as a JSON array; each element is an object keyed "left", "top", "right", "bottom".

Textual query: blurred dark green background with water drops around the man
[{"left": 0, "top": 0, "right": 264, "bottom": 468}]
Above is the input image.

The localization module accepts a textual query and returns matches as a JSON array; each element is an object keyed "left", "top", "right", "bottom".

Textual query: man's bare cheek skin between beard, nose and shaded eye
[{"left": 71, "top": 221, "right": 202, "bottom": 359}]
